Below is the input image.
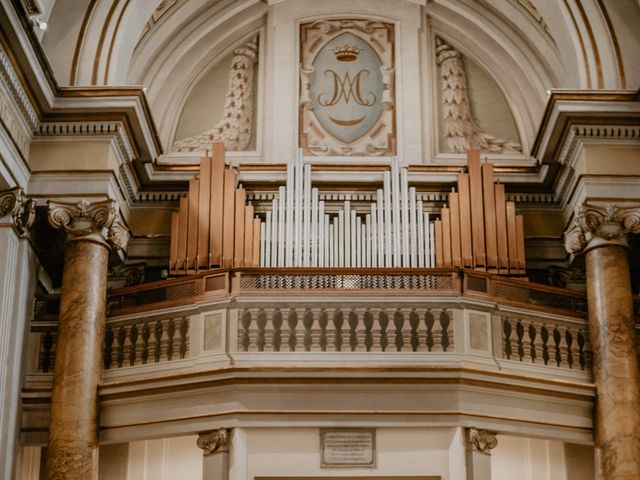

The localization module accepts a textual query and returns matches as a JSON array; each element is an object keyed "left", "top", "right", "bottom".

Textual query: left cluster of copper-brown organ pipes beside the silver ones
[{"left": 169, "top": 143, "right": 260, "bottom": 275}]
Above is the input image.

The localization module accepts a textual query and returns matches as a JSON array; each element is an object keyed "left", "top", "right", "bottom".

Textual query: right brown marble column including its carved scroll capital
[{"left": 565, "top": 204, "right": 640, "bottom": 480}]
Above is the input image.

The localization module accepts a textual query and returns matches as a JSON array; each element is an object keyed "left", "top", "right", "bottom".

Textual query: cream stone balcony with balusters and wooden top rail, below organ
[{"left": 23, "top": 268, "right": 595, "bottom": 442}]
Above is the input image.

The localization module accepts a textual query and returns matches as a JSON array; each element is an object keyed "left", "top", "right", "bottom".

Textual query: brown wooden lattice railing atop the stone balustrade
[{"left": 34, "top": 268, "right": 587, "bottom": 320}]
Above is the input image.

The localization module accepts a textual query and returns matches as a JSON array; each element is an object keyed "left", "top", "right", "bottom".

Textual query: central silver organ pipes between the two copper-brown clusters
[{"left": 260, "top": 152, "right": 435, "bottom": 268}]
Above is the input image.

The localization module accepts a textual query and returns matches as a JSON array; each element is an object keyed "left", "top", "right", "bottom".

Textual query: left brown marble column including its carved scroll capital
[{"left": 47, "top": 200, "right": 127, "bottom": 480}]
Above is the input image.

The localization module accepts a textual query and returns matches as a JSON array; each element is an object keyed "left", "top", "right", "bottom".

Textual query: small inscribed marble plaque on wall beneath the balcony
[{"left": 320, "top": 429, "right": 376, "bottom": 468}]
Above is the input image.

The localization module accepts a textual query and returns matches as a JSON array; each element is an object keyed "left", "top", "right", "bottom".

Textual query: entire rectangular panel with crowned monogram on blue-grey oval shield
[{"left": 300, "top": 20, "right": 395, "bottom": 156}]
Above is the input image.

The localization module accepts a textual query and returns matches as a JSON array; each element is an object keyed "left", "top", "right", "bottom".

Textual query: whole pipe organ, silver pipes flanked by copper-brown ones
[{"left": 170, "top": 143, "right": 525, "bottom": 275}]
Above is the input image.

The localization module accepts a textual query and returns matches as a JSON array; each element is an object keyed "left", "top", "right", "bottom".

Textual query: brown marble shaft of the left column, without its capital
[{"left": 47, "top": 240, "right": 109, "bottom": 480}]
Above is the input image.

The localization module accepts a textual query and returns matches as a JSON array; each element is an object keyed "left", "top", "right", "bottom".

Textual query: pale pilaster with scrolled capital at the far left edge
[{"left": 0, "top": 187, "right": 36, "bottom": 478}]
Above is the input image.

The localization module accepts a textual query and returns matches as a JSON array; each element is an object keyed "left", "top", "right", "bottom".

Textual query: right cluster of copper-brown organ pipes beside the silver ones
[{"left": 435, "top": 150, "right": 525, "bottom": 275}]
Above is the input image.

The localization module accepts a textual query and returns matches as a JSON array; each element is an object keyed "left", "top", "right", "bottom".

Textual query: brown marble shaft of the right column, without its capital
[{"left": 585, "top": 244, "right": 640, "bottom": 480}]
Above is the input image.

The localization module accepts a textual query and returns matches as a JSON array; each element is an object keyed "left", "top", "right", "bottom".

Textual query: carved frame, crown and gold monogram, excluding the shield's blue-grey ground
[{"left": 299, "top": 19, "right": 396, "bottom": 156}]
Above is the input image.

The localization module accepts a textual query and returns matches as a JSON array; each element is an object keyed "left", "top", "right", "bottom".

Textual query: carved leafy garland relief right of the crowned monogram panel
[{"left": 436, "top": 37, "right": 522, "bottom": 154}]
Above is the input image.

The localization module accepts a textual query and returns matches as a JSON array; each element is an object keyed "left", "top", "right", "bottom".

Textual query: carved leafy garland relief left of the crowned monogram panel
[{"left": 172, "top": 36, "right": 258, "bottom": 152}]
